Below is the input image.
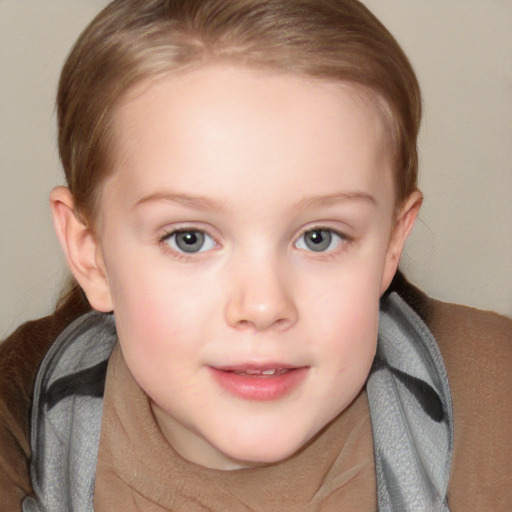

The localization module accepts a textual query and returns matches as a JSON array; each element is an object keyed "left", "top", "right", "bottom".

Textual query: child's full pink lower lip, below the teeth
[{"left": 210, "top": 367, "right": 309, "bottom": 402}]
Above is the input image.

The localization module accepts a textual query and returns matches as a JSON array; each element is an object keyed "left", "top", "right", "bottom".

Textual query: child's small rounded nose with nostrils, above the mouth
[{"left": 226, "top": 256, "right": 298, "bottom": 331}]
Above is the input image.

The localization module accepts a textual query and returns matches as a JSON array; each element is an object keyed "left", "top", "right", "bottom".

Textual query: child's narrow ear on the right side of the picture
[{"left": 380, "top": 190, "right": 423, "bottom": 295}]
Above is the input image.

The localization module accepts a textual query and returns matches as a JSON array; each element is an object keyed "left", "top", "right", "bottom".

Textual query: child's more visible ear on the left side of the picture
[{"left": 50, "top": 187, "right": 113, "bottom": 312}]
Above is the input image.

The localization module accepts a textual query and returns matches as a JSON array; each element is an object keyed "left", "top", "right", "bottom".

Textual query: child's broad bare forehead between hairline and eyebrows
[{"left": 103, "top": 65, "right": 392, "bottom": 212}]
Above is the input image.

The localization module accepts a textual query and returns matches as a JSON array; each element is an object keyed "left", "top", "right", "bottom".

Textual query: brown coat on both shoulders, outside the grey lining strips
[{"left": 0, "top": 275, "right": 512, "bottom": 512}]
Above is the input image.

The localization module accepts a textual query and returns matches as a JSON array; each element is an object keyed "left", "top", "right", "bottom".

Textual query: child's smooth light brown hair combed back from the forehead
[{"left": 57, "top": 0, "right": 421, "bottom": 312}]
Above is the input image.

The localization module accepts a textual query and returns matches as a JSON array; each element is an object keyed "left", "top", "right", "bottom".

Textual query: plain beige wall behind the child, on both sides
[{"left": 0, "top": 0, "right": 512, "bottom": 337}]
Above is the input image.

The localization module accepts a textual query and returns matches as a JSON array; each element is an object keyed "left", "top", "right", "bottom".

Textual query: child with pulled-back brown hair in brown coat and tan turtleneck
[{"left": 0, "top": 0, "right": 512, "bottom": 511}]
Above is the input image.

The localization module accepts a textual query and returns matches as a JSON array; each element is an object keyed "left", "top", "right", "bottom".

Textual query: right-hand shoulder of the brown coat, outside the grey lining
[{"left": 392, "top": 276, "right": 512, "bottom": 512}]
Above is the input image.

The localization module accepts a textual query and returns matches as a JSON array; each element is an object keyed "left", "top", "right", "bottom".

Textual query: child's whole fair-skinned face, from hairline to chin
[{"left": 93, "top": 66, "right": 412, "bottom": 468}]
